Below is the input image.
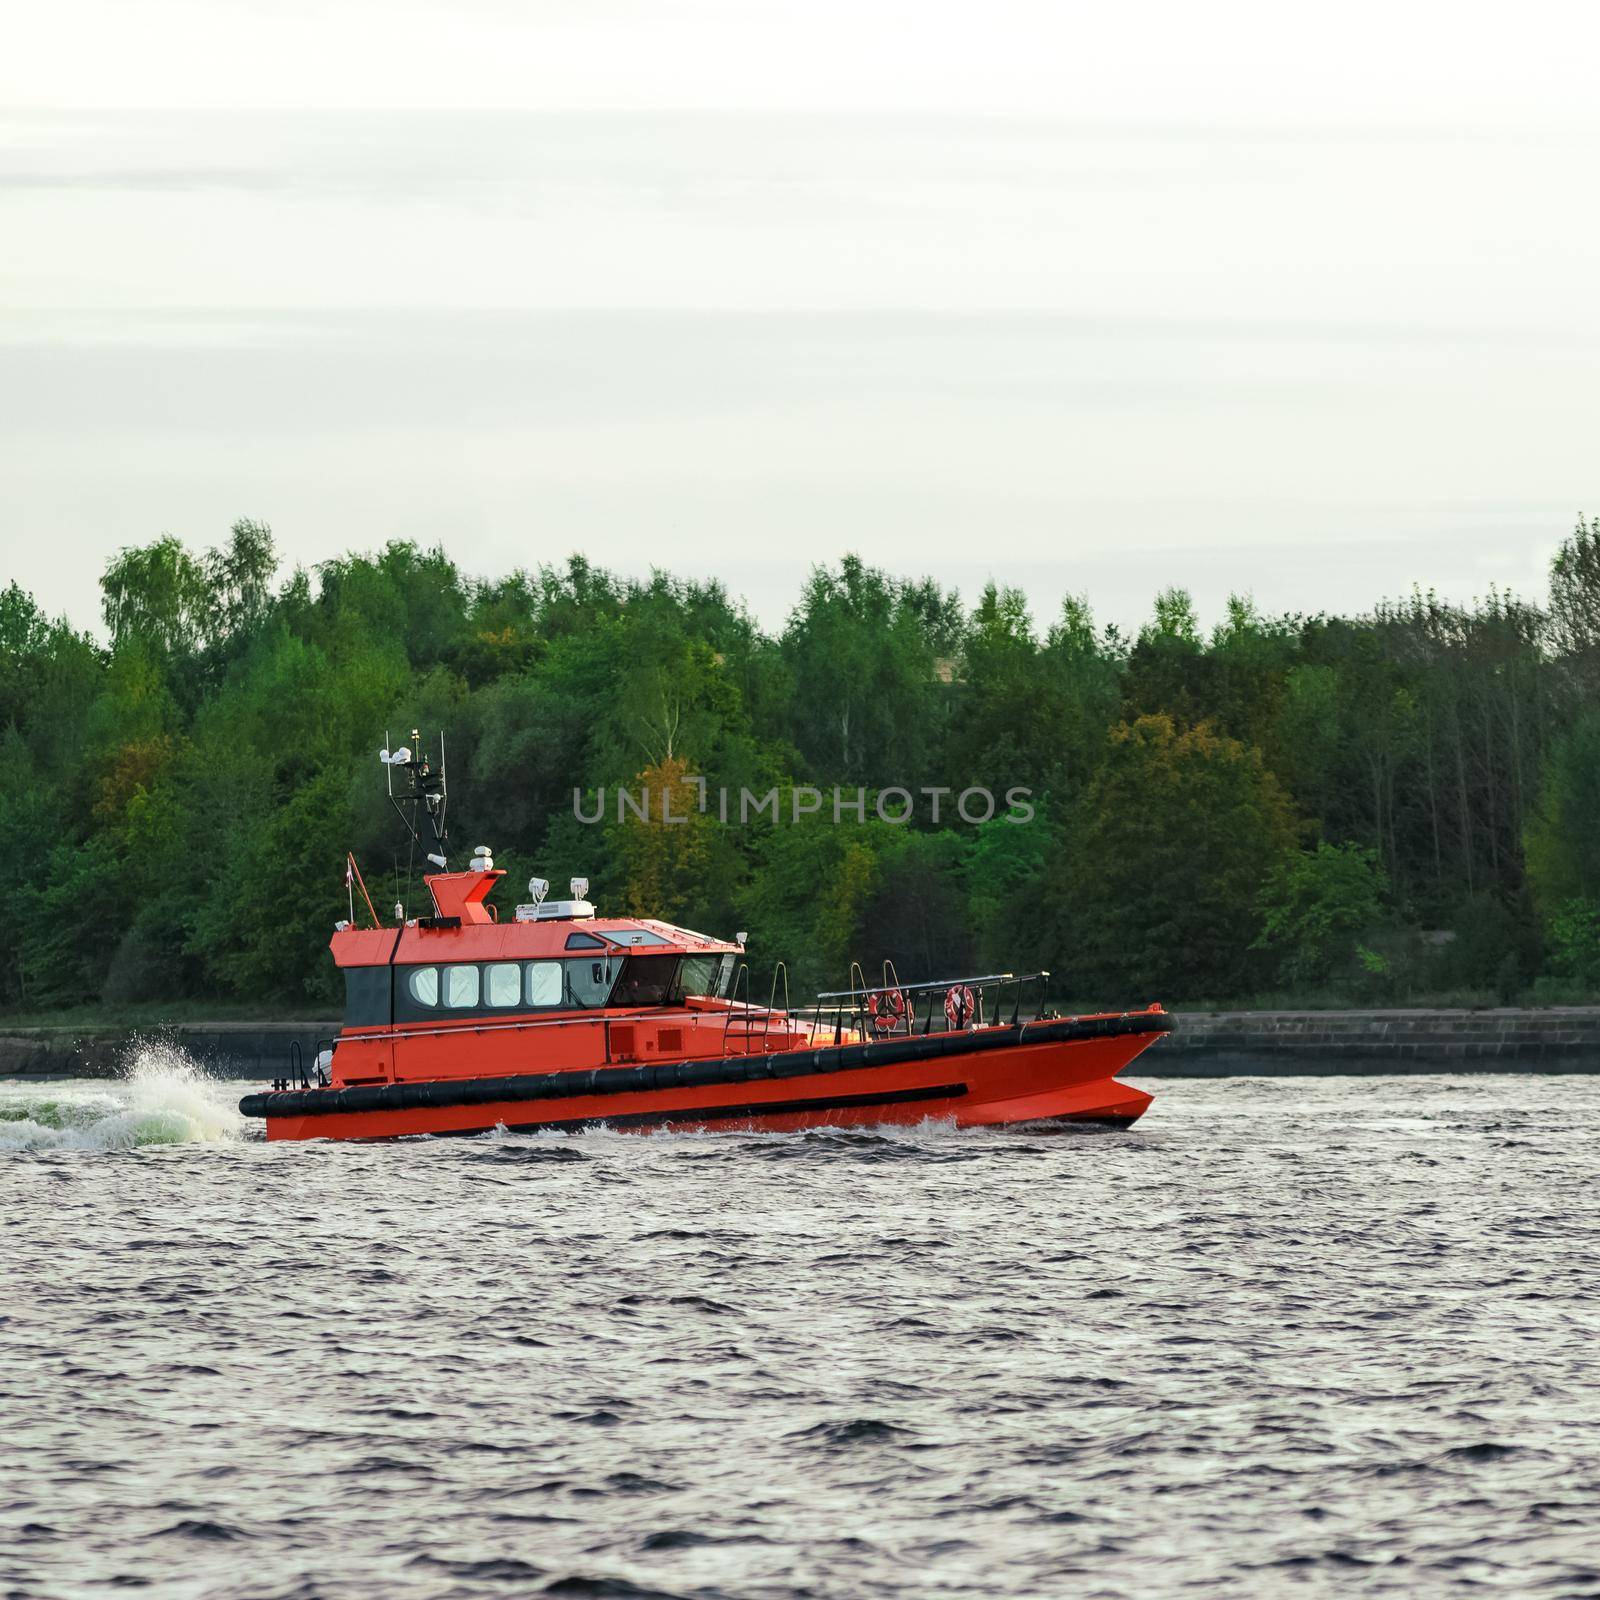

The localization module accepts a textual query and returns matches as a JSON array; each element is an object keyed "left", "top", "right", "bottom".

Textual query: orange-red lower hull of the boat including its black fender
[{"left": 240, "top": 1013, "right": 1171, "bottom": 1139}]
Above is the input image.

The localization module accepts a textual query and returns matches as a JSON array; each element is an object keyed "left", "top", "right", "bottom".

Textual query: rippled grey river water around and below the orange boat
[{"left": 0, "top": 1053, "right": 1600, "bottom": 1600}]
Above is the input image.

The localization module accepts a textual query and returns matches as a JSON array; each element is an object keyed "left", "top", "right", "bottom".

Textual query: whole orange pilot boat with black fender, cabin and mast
[{"left": 240, "top": 736, "right": 1173, "bottom": 1139}]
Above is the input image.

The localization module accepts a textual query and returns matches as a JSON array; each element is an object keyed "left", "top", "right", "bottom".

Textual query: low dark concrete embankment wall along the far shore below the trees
[{"left": 0, "top": 1006, "right": 1600, "bottom": 1078}]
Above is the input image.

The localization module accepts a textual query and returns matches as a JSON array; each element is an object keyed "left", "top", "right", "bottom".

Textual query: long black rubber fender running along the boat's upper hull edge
[{"left": 238, "top": 1011, "right": 1173, "bottom": 1117}]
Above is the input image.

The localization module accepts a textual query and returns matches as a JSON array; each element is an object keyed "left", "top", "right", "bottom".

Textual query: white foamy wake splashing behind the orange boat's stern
[{"left": 0, "top": 1042, "right": 245, "bottom": 1154}]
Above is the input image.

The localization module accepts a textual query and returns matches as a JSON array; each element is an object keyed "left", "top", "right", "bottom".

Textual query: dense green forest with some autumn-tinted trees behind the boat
[{"left": 0, "top": 522, "right": 1600, "bottom": 1016}]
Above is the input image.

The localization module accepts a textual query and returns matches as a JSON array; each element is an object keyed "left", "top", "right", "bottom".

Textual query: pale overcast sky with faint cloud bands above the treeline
[{"left": 0, "top": 0, "right": 1600, "bottom": 636}]
